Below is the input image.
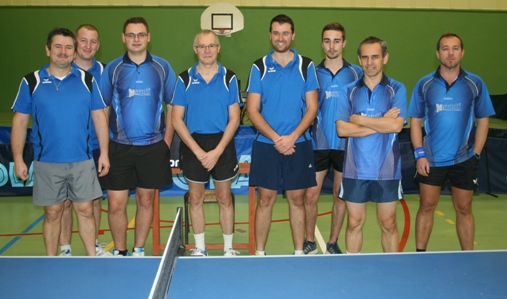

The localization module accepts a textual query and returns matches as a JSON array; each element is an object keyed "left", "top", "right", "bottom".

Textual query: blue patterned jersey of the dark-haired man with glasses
[{"left": 100, "top": 53, "right": 176, "bottom": 145}]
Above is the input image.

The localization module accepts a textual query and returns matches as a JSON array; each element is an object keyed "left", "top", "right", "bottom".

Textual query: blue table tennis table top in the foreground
[{"left": 0, "top": 251, "right": 507, "bottom": 299}]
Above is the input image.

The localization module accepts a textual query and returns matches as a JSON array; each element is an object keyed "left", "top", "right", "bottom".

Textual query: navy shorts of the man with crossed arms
[{"left": 338, "top": 178, "right": 403, "bottom": 203}]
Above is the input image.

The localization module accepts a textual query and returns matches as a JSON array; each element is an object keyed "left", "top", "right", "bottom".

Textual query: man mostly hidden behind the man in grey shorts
[{"left": 60, "top": 24, "right": 111, "bottom": 256}]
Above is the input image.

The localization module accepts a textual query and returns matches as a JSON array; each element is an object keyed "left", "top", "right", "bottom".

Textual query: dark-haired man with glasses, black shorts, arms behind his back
[{"left": 100, "top": 17, "right": 176, "bottom": 256}]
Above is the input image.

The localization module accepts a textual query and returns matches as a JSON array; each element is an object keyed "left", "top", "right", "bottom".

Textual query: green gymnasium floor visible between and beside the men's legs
[{"left": 0, "top": 194, "right": 507, "bottom": 256}]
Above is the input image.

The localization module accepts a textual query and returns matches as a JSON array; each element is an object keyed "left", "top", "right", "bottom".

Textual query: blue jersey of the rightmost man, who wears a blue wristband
[{"left": 408, "top": 67, "right": 495, "bottom": 166}]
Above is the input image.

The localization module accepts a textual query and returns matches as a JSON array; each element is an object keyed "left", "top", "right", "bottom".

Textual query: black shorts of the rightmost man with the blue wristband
[{"left": 415, "top": 157, "right": 479, "bottom": 190}]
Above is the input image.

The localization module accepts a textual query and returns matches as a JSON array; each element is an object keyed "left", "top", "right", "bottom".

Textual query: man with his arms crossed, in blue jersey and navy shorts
[{"left": 336, "top": 36, "right": 407, "bottom": 253}]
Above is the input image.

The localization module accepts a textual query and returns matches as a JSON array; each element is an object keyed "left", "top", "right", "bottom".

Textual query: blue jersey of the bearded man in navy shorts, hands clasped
[{"left": 247, "top": 49, "right": 319, "bottom": 144}]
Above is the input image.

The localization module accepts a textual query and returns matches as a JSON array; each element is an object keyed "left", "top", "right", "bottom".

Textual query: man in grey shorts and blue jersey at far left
[{"left": 11, "top": 28, "right": 109, "bottom": 256}]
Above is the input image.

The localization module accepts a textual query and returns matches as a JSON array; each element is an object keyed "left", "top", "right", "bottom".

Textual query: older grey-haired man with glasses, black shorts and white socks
[{"left": 171, "top": 30, "right": 240, "bottom": 256}]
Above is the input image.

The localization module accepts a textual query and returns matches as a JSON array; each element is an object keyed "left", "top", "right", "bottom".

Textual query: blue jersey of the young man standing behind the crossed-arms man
[{"left": 310, "top": 59, "right": 363, "bottom": 150}]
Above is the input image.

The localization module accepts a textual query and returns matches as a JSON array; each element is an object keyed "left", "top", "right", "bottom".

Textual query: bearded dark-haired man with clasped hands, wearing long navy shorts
[{"left": 247, "top": 15, "right": 319, "bottom": 255}]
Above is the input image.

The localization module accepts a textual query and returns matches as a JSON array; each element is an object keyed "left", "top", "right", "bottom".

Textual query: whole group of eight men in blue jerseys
[{"left": 11, "top": 14, "right": 495, "bottom": 256}]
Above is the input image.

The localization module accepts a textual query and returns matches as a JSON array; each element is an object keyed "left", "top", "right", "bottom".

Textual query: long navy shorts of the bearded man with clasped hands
[{"left": 249, "top": 140, "right": 317, "bottom": 190}]
